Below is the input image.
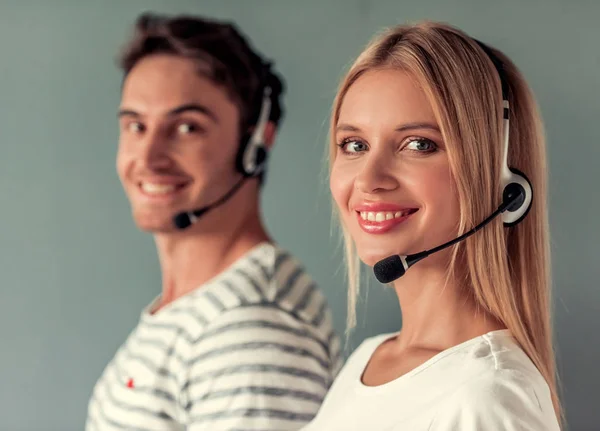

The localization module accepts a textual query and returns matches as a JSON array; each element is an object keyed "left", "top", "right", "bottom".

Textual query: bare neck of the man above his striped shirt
[{"left": 154, "top": 210, "right": 269, "bottom": 311}]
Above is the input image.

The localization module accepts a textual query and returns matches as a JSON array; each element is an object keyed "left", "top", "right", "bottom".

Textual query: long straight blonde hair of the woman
[{"left": 329, "top": 21, "right": 562, "bottom": 420}]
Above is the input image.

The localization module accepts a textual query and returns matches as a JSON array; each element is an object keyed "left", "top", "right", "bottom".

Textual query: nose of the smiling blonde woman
[{"left": 354, "top": 151, "right": 399, "bottom": 194}]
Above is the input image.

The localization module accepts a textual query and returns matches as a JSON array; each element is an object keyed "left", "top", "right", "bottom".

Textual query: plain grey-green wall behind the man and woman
[{"left": 0, "top": 0, "right": 600, "bottom": 431}]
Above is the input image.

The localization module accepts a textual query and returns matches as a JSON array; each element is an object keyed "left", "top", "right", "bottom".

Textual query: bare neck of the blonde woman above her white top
[{"left": 394, "top": 256, "right": 504, "bottom": 351}]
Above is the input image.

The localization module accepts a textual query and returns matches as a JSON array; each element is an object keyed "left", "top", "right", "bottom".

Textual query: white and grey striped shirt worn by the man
[{"left": 86, "top": 243, "right": 341, "bottom": 431}]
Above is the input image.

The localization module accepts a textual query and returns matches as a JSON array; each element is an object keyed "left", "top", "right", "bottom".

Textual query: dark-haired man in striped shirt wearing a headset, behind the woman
[{"left": 86, "top": 14, "right": 340, "bottom": 431}]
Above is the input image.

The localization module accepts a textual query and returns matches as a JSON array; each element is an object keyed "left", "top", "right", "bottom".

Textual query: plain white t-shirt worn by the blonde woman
[{"left": 302, "top": 330, "right": 560, "bottom": 431}]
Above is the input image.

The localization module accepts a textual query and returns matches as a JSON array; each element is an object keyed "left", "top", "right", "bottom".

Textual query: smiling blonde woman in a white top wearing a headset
[{"left": 305, "top": 22, "right": 561, "bottom": 431}]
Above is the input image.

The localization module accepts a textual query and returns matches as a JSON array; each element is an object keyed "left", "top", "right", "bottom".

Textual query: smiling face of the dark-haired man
[{"left": 117, "top": 55, "right": 240, "bottom": 233}]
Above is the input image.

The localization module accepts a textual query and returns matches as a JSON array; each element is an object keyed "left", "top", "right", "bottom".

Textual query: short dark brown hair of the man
[{"left": 119, "top": 13, "right": 284, "bottom": 135}]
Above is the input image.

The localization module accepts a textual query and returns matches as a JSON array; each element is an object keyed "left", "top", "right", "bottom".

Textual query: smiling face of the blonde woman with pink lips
[{"left": 330, "top": 69, "right": 459, "bottom": 266}]
